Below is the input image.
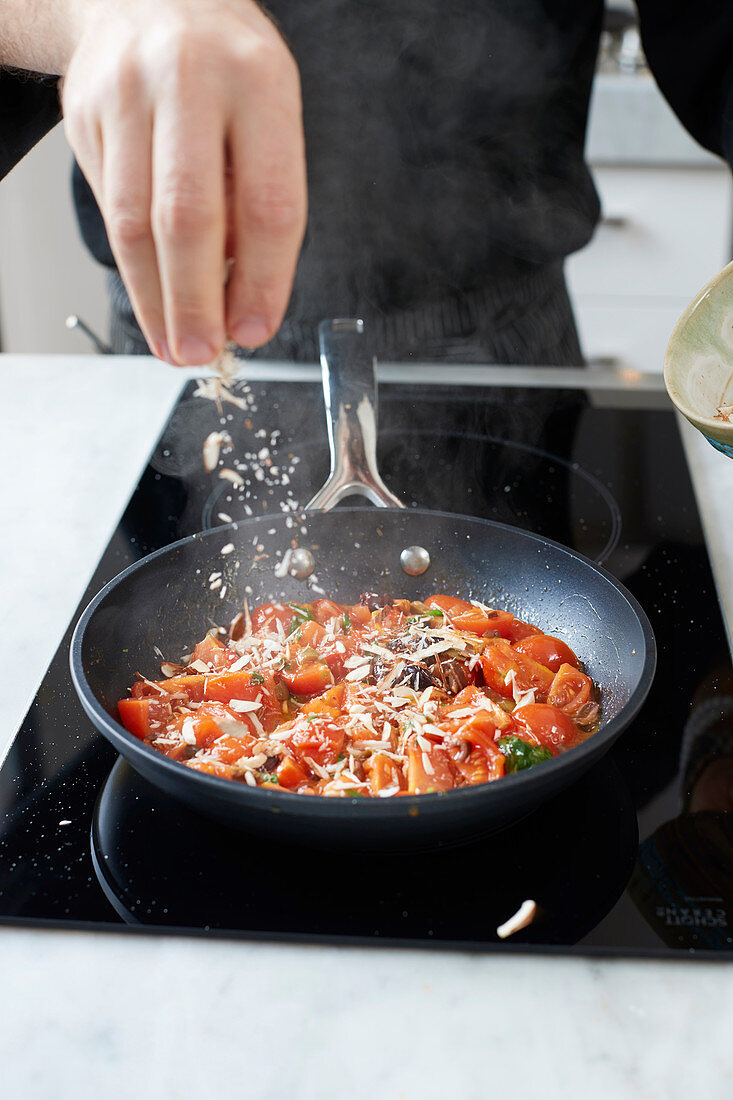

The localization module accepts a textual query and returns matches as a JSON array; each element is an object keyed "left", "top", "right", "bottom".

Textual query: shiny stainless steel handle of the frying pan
[{"left": 306, "top": 318, "right": 405, "bottom": 512}]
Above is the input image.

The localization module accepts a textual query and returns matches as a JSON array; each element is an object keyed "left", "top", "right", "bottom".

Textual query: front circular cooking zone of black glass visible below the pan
[{"left": 91, "top": 760, "right": 638, "bottom": 945}]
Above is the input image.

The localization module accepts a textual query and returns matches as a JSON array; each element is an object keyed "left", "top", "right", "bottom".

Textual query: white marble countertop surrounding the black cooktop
[{"left": 0, "top": 356, "right": 733, "bottom": 1100}]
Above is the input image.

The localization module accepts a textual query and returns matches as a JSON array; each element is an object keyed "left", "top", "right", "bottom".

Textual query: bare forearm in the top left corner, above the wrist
[{"left": 0, "top": 0, "right": 83, "bottom": 76}]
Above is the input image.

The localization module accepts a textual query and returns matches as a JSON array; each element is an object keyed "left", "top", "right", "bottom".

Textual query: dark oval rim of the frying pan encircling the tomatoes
[{"left": 69, "top": 506, "right": 657, "bottom": 817}]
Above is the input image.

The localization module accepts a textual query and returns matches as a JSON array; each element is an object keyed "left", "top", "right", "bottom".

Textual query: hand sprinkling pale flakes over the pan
[{"left": 62, "top": 0, "right": 306, "bottom": 365}]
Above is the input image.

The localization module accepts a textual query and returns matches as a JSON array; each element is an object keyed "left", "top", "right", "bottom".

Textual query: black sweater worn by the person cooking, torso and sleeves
[{"left": 0, "top": 0, "right": 733, "bottom": 319}]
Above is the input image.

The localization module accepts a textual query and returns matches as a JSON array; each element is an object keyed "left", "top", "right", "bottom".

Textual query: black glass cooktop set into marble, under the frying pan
[{"left": 0, "top": 382, "right": 733, "bottom": 958}]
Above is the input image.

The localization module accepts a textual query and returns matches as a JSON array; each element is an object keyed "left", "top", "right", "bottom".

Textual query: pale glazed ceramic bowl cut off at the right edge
[{"left": 665, "top": 263, "right": 733, "bottom": 459}]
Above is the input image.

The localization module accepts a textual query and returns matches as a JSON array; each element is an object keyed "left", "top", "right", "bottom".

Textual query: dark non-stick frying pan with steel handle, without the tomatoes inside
[{"left": 70, "top": 320, "right": 656, "bottom": 848}]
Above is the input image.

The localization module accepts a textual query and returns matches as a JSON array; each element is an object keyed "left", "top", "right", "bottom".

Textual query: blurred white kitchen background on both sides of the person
[{"left": 0, "top": 0, "right": 733, "bottom": 372}]
